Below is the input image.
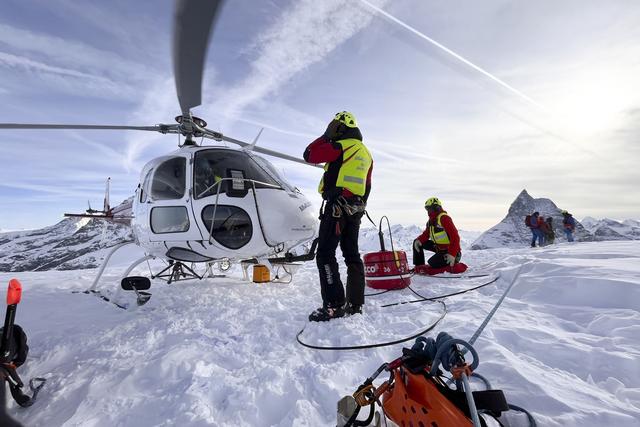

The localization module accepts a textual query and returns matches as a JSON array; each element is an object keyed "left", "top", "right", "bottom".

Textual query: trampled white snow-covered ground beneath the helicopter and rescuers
[{"left": 0, "top": 241, "right": 640, "bottom": 427}]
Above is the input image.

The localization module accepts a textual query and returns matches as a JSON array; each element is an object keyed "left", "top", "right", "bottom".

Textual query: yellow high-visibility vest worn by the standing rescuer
[{"left": 318, "top": 138, "right": 373, "bottom": 196}]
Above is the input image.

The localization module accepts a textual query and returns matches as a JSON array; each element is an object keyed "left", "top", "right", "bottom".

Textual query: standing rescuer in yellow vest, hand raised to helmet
[{"left": 304, "top": 111, "right": 373, "bottom": 322}]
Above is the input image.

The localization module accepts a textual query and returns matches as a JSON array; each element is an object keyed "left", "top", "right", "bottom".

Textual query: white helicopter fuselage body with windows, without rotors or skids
[{"left": 131, "top": 146, "right": 317, "bottom": 262}]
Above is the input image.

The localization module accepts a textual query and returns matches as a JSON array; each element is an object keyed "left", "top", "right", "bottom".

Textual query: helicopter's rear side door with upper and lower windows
[{"left": 147, "top": 156, "right": 202, "bottom": 242}]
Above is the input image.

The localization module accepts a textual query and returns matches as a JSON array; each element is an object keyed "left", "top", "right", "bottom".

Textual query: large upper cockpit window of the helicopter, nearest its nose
[{"left": 193, "top": 149, "right": 280, "bottom": 199}]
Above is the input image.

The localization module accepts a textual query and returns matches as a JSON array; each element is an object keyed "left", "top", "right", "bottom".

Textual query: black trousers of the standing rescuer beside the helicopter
[{"left": 316, "top": 202, "right": 364, "bottom": 308}]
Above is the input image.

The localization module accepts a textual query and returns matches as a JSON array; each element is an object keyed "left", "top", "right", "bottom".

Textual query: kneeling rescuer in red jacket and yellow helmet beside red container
[{"left": 413, "top": 197, "right": 466, "bottom": 274}]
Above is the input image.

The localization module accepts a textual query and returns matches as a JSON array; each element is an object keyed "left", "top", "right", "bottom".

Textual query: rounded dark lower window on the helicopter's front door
[{"left": 202, "top": 205, "right": 253, "bottom": 249}]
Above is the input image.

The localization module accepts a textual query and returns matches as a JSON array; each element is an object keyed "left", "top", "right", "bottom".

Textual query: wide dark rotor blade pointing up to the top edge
[{"left": 173, "top": 0, "right": 222, "bottom": 115}]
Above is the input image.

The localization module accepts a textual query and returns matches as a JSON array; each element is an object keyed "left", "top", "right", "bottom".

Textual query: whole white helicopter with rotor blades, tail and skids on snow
[{"left": 0, "top": 0, "right": 317, "bottom": 305}]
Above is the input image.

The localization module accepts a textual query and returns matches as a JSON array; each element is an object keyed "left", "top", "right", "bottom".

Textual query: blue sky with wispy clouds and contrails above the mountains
[{"left": 0, "top": 0, "right": 640, "bottom": 230}]
